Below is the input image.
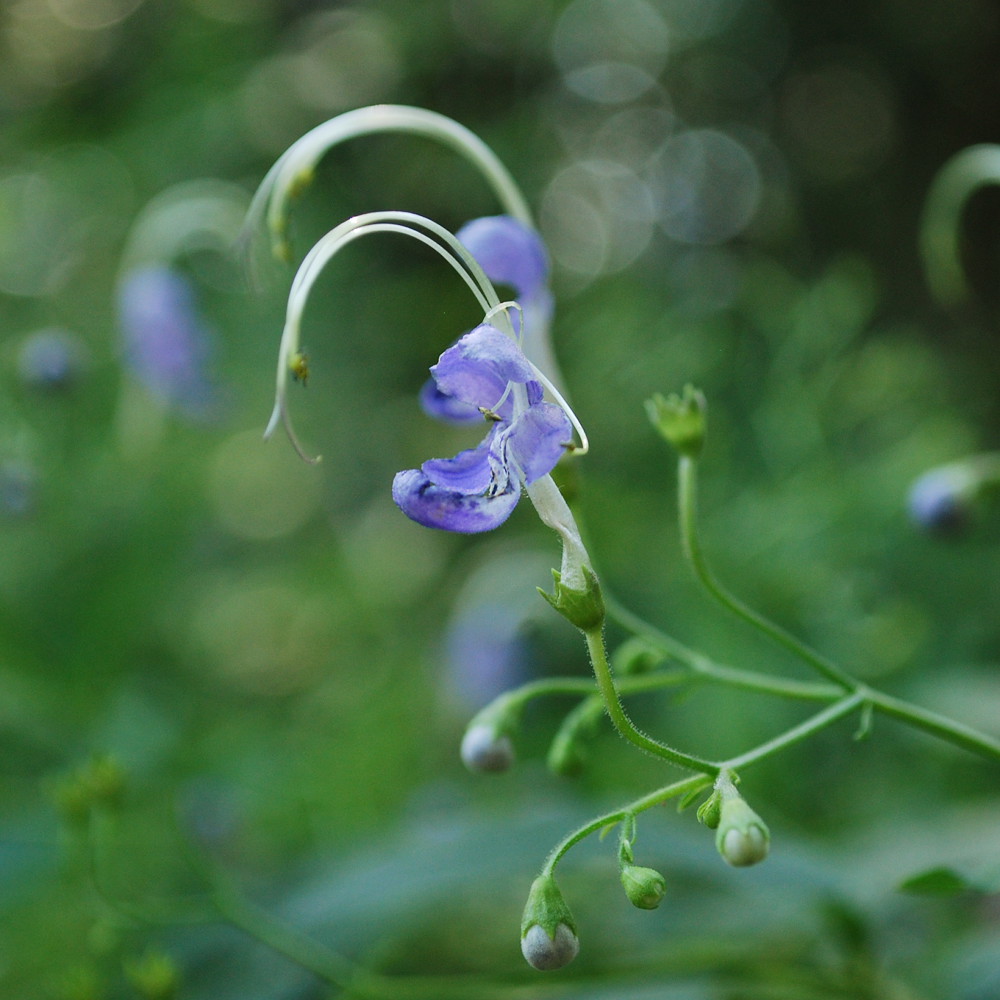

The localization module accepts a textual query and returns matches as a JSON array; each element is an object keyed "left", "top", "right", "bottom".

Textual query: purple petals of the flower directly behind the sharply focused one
[{"left": 420, "top": 215, "right": 552, "bottom": 424}]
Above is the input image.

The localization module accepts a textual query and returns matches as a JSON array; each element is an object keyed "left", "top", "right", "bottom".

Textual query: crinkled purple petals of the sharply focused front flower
[{"left": 392, "top": 323, "right": 573, "bottom": 533}]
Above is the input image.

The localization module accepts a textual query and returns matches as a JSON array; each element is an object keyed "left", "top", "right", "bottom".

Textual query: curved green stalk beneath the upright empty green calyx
[{"left": 678, "top": 455, "right": 858, "bottom": 691}]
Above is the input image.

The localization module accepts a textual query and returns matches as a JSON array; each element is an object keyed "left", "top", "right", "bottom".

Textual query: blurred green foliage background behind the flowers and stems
[{"left": 0, "top": 0, "right": 1000, "bottom": 1000}]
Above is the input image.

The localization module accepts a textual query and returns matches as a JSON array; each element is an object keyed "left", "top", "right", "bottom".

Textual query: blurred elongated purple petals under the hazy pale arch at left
[{"left": 118, "top": 265, "right": 218, "bottom": 418}]
